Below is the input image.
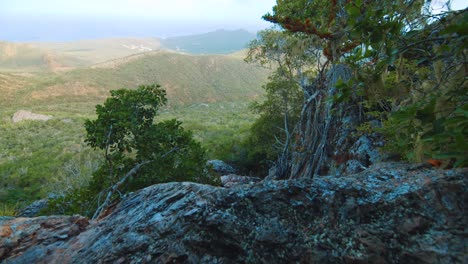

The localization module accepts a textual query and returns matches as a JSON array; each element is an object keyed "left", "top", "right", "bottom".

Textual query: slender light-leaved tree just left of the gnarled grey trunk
[{"left": 245, "top": 29, "right": 320, "bottom": 175}]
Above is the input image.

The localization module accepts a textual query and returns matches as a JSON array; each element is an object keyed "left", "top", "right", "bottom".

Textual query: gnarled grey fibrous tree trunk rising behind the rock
[{"left": 289, "top": 64, "right": 359, "bottom": 178}]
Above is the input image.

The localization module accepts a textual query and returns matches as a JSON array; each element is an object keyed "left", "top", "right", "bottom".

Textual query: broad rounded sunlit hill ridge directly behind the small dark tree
[{"left": 7, "top": 52, "right": 268, "bottom": 112}]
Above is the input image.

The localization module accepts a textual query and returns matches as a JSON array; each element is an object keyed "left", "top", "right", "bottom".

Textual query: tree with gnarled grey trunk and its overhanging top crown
[{"left": 264, "top": 0, "right": 442, "bottom": 178}]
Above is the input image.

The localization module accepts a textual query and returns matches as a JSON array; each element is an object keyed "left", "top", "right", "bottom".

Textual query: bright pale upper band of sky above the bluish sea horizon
[{"left": 0, "top": 0, "right": 276, "bottom": 22}]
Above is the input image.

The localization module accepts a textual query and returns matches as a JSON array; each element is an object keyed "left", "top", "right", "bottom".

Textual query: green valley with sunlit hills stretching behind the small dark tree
[{"left": 0, "top": 29, "right": 270, "bottom": 210}]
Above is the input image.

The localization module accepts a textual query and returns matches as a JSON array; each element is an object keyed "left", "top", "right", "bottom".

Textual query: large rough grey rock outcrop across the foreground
[{"left": 0, "top": 163, "right": 468, "bottom": 263}]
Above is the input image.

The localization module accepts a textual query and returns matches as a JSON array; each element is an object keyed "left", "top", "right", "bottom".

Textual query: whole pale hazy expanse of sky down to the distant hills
[{"left": 0, "top": 0, "right": 467, "bottom": 41}]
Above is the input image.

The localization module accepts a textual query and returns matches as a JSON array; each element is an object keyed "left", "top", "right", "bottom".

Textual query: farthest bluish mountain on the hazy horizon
[{"left": 161, "top": 29, "right": 255, "bottom": 54}]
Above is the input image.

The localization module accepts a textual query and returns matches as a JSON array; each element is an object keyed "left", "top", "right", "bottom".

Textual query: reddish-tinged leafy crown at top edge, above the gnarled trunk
[{"left": 264, "top": 0, "right": 423, "bottom": 63}]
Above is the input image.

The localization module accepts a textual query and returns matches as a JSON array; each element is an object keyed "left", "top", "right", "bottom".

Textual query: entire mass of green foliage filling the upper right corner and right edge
[{"left": 264, "top": 0, "right": 468, "bottom": 169}]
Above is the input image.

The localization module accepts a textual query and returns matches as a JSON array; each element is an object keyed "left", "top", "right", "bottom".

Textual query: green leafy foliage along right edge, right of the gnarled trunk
[{"left": 360, "top": 11, "right": 468, "bottom": 166}]
